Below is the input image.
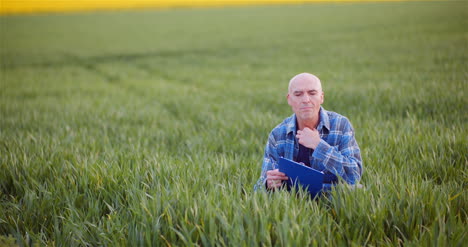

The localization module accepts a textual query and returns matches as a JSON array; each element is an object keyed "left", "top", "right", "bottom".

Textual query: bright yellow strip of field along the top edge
[{"left": 0, "top": 0, "right": 410, "bottom": 14}]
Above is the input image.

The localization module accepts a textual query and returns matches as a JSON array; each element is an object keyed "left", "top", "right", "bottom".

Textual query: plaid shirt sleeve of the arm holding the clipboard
[{"left": 254, "top": 133, "right": 279, "bottom": 191}]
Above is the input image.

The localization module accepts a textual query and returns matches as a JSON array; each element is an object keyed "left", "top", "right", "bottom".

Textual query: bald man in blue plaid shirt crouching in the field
[{"left": 255, "top": 73, "right": 362, "bottom": 191}]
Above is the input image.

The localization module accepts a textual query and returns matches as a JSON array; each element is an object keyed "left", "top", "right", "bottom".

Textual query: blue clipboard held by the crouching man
[{"left": 279, "top": 157, "right": 324, "bottom": 197}]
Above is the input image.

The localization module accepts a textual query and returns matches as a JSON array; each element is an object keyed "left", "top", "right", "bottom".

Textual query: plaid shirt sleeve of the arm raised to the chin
[{"left": 312, "top": 118, "right": 362, "bottom": 184}]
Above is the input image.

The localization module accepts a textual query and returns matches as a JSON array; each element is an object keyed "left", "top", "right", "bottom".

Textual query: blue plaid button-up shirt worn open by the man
[{"left": 255, "top": 107, "right": 362, "bottom": 191}]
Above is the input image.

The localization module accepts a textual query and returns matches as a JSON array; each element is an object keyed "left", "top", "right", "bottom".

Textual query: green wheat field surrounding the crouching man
[{"left": 0, "top": 1, "right": 468, "bottom": 246}]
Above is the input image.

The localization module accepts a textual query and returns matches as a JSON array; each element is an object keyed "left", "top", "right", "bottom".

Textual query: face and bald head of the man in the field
[{"left": 288, "top": 77, "right": 324, "bottom": 120}]
